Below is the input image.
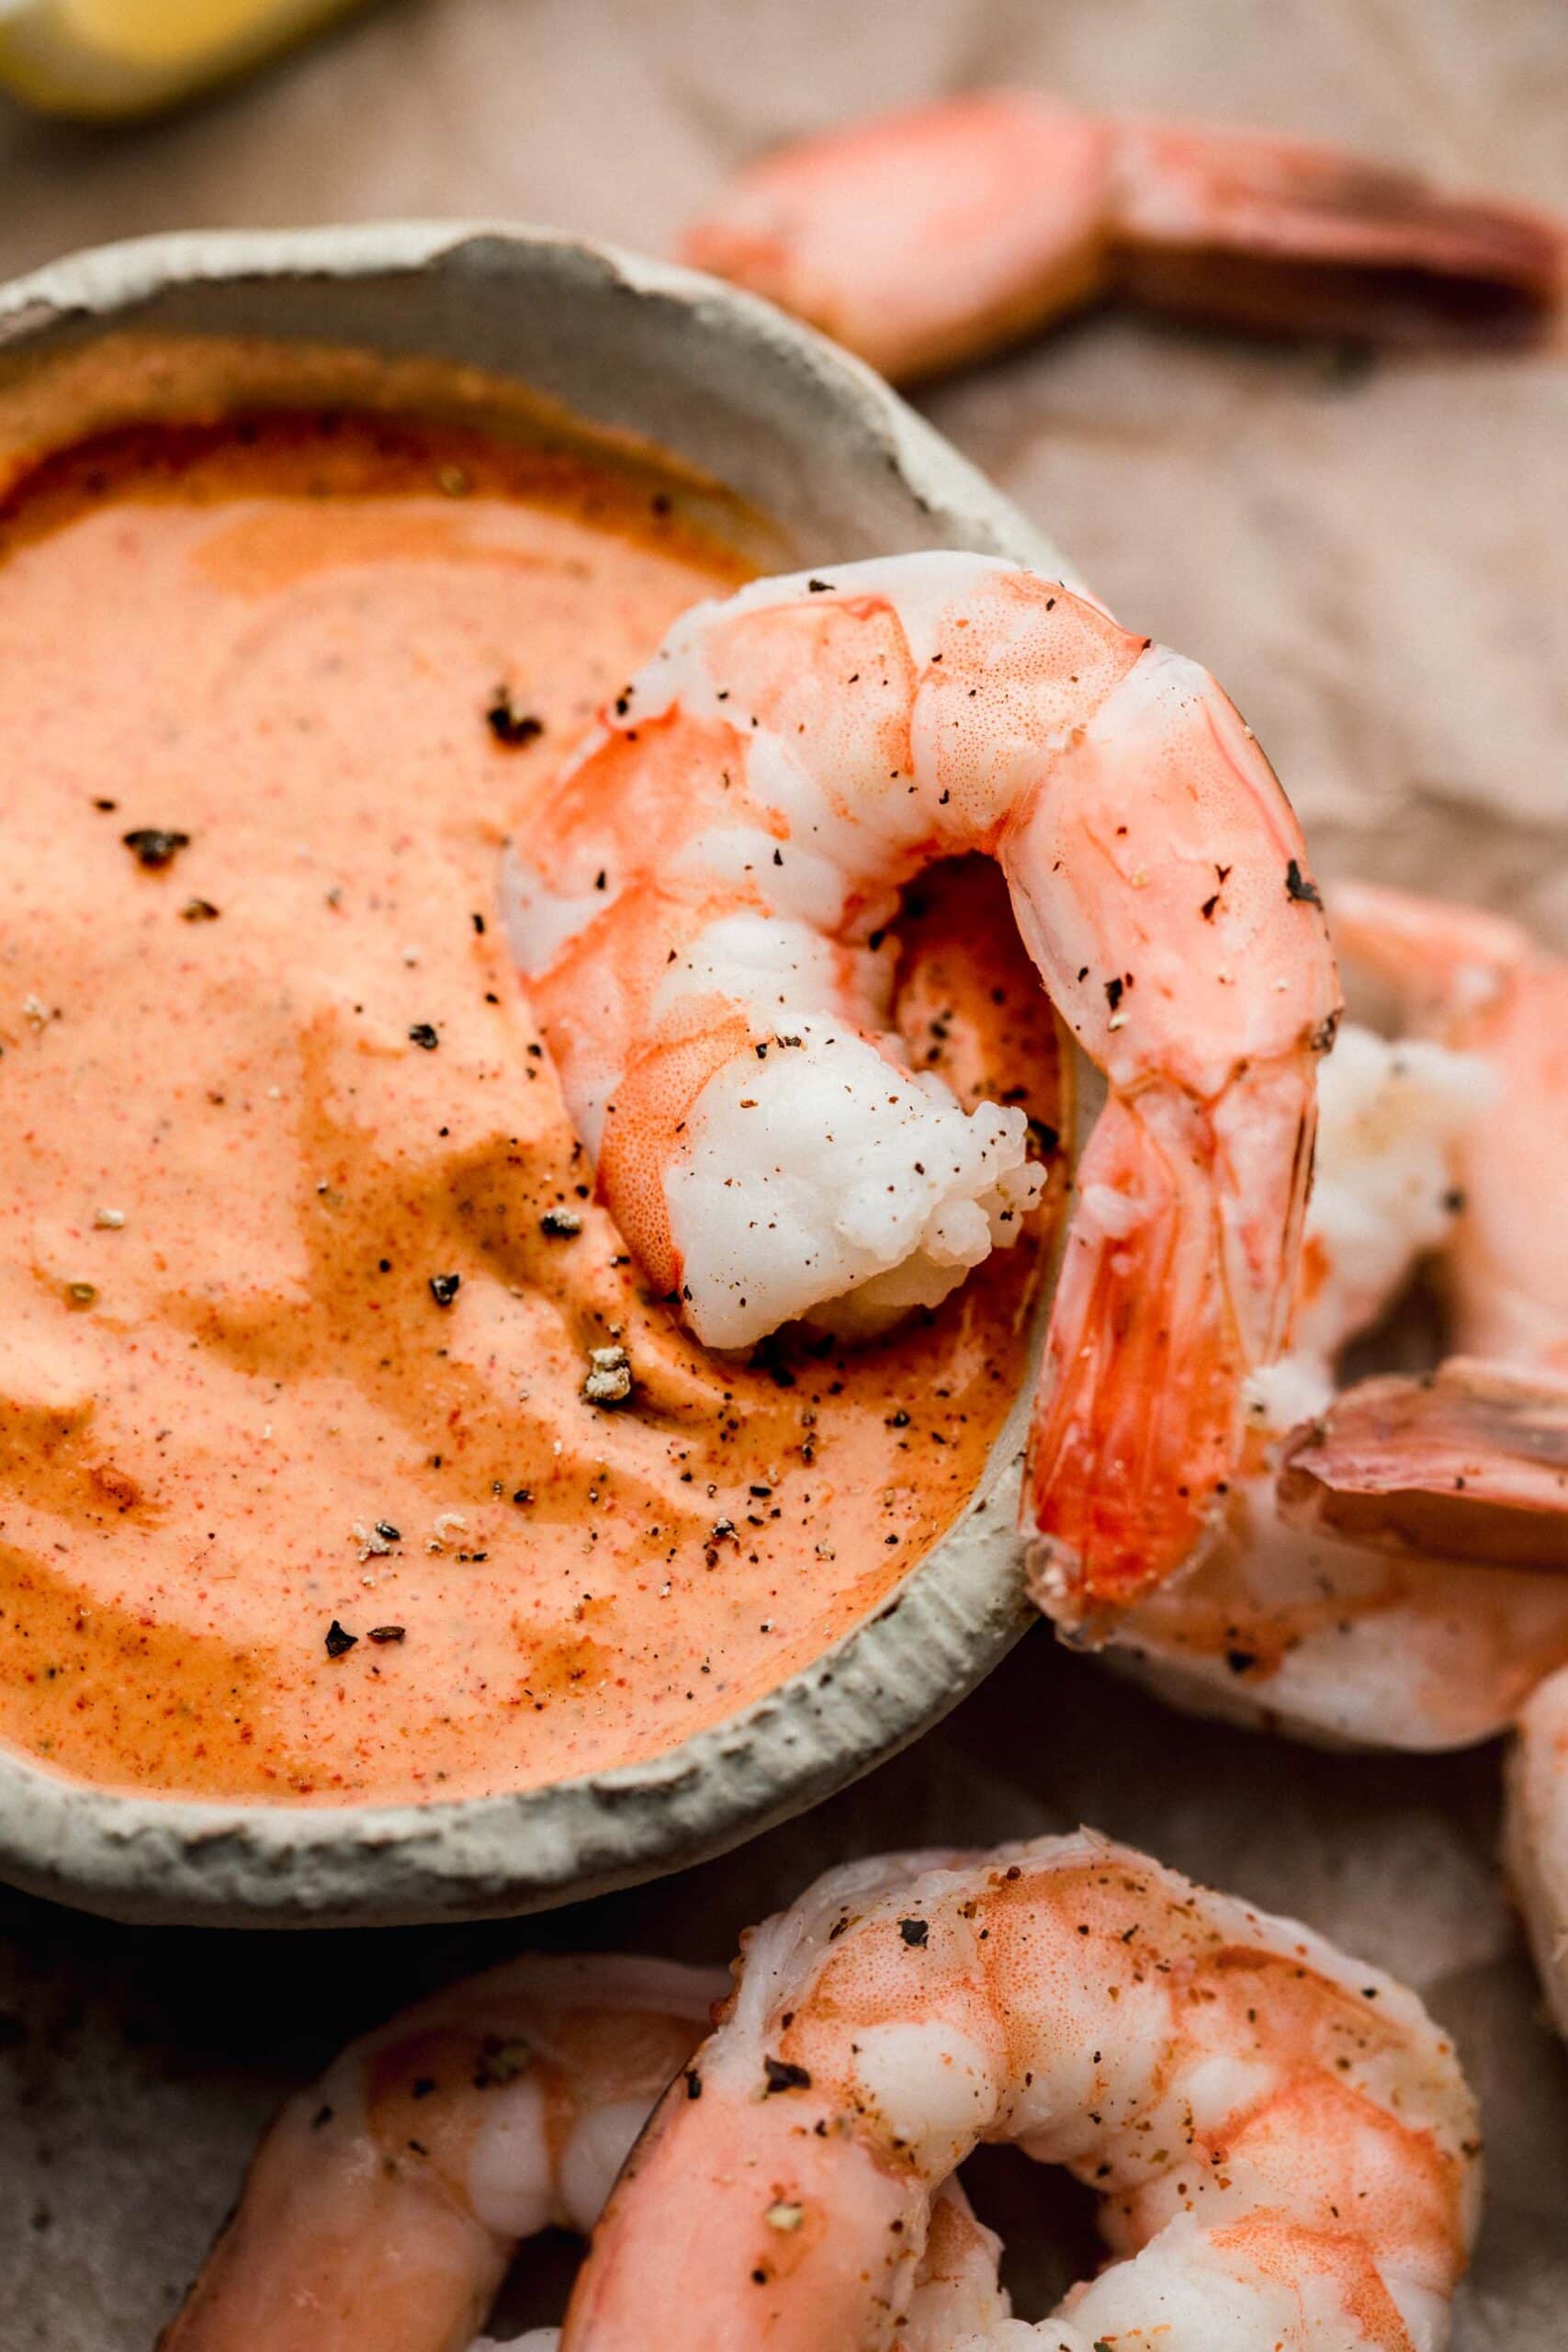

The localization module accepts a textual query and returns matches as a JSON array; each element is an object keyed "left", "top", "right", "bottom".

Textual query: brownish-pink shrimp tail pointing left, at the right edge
[{"left": 1279, "top": 1357, "right": 1568, "bottom": 1571}]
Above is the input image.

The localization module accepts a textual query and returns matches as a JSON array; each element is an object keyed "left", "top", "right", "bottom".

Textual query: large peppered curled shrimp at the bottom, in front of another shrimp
[{"left": 562, "top": 1832, "right": 1479, "bottom": 2352}]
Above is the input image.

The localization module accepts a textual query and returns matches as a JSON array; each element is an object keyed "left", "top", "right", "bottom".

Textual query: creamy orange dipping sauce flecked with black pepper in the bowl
[{"left": 0, "top": 414, "right": 1060, "bottom": 1804}]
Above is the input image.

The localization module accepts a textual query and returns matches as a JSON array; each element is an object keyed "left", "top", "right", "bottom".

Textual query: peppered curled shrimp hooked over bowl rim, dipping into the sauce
[{"left": 508, "top": 553, "right": 1337, "bottom": 1618}]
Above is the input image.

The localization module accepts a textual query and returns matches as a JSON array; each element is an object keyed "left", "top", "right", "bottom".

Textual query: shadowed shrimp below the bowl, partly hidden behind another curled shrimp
[{"left": 163, "top": 1954, "right": 724, "bottom": 2352}]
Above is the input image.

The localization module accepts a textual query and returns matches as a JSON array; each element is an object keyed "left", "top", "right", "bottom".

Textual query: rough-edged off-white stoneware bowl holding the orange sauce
[{"left": 0, "top": 223, "right": 1081, "bottom": 1927}]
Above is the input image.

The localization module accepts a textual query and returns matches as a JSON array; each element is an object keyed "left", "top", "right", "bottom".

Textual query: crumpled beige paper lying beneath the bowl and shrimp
[{"left": 0, "top": 0, "right": 1568, "bottom": 2352}]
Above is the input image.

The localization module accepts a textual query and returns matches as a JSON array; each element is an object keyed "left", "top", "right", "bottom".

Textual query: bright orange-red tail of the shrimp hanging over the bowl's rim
[{"left": 1022, "top": 1070, "right": 1314, "bottom": 1639}]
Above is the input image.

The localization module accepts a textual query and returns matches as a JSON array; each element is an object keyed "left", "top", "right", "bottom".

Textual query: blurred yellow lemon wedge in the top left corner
[{"left": 0, "top": 0, "right": 355, "bottom": 120}]
